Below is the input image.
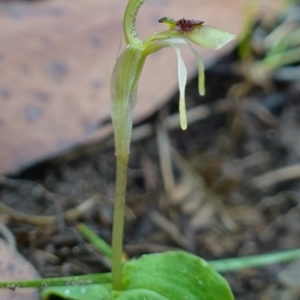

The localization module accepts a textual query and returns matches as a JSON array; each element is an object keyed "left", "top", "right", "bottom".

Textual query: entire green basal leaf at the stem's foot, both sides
[{"left": 42, "top": 251, "right": 233, "bottom": 300}]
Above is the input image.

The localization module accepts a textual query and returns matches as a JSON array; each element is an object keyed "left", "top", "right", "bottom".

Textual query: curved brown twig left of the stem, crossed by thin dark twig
[{"left": 0, "top": 195, "right": 100, "bottom": 226}]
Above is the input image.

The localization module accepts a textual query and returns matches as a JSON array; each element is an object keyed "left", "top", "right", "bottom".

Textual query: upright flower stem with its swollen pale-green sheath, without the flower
[{"left": 111, "top": 45, "right": 145, "bottom": 290}]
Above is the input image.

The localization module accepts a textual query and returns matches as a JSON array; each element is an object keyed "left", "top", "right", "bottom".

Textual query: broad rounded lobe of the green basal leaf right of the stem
[{"left": 122, "top": 251, "right": 233, "bottom": 300}]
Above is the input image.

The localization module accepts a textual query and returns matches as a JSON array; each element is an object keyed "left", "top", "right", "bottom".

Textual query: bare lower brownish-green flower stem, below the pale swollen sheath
[{"left": 112, "top": 155, "right": 128, "bottom": 290}]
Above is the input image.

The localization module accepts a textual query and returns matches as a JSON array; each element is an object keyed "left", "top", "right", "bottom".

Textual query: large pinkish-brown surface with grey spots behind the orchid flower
[{"left": 0, "top": 0, "right": 278, "bottom": 174}]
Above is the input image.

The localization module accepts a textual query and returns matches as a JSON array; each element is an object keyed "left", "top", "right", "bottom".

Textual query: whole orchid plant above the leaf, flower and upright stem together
[{"left": 111, "top": 0, "right": 236, "bottom": 289}]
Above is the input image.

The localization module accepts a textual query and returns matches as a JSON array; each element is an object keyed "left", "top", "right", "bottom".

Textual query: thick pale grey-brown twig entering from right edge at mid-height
[{"left": 252, "top": 164, "right": 300, "bottom": 189}]
